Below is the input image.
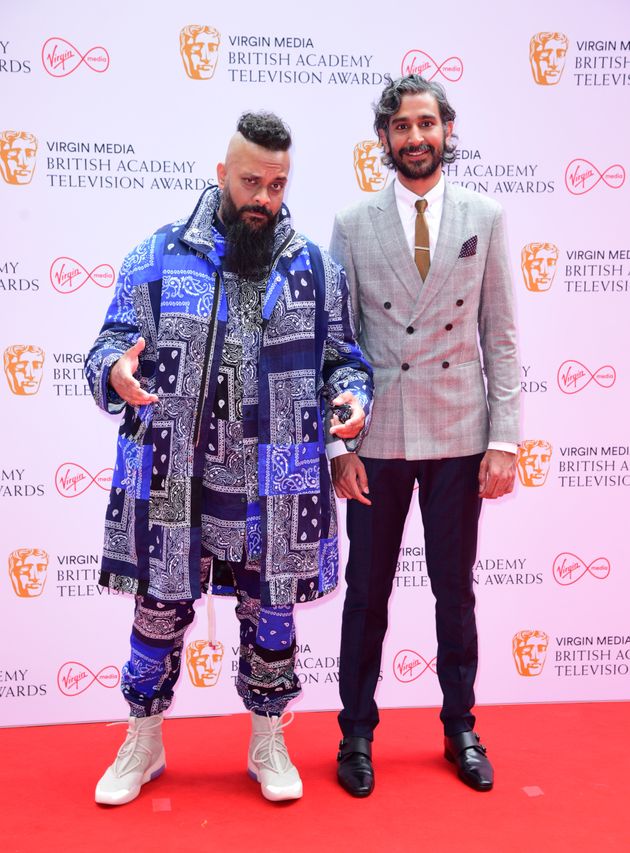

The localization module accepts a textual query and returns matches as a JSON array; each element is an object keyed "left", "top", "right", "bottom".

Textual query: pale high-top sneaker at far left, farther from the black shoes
[{"left": 95, "top": 714, "right": 166, "bottom": 806}]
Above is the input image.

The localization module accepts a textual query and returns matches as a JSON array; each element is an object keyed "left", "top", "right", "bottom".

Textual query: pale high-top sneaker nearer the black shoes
[{"left": 247, "top": 711, "right": 302, "bottom": 801}]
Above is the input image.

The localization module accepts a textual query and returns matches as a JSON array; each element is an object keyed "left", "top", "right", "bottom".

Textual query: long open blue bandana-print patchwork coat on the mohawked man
[{"left": 86, "top": 187, "right": 372, "bottom": 605}]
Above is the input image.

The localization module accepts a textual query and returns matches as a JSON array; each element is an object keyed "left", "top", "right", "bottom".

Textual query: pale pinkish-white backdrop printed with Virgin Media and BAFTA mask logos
[{"left": 0, "top": 0, "right": 630, "bottom": 725}]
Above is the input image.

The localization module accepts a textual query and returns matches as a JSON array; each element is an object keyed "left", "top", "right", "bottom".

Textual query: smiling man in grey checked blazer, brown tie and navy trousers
[{"left": 329, "top": 74, "right": 519, "bottom": 797}]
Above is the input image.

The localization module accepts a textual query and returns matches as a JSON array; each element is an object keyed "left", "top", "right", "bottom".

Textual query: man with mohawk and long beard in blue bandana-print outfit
[{"left": 86, "top": 113, "right": 372, "bottom": 805}]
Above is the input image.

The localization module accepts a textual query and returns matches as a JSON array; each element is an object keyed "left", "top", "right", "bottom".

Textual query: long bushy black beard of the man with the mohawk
[{"left": 221, "top": 186, "right": 277, "bottom": 278}]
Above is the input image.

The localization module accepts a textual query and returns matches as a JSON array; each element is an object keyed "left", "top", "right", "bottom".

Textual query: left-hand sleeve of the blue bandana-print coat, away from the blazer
[{"left": 85, "top": 235, "right": 155, "bottom": 415}]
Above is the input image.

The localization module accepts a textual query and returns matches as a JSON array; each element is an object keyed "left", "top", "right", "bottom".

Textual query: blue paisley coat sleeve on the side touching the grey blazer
[{"left": 322, "top": 241, "right": 374, "bottom": 450}]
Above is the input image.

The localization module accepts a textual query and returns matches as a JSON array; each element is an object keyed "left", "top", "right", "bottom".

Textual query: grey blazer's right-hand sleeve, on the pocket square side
[{"left": 479, "top": 208, "right": 520, "bottom": 444}]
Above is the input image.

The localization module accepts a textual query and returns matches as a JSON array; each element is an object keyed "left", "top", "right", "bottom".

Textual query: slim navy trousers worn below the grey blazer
[{"left": 339, "top": 454, "right": 483, "bottom": 740}]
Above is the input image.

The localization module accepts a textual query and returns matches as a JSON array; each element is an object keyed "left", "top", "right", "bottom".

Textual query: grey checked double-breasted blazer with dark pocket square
[{"left": 330, "top": 182, "right": 520, "bottom": 459}]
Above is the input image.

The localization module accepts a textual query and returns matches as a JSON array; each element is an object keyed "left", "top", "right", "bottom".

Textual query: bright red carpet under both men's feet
[{"left": 0, "top": 703, "right": 630, "bottom": 853}]
